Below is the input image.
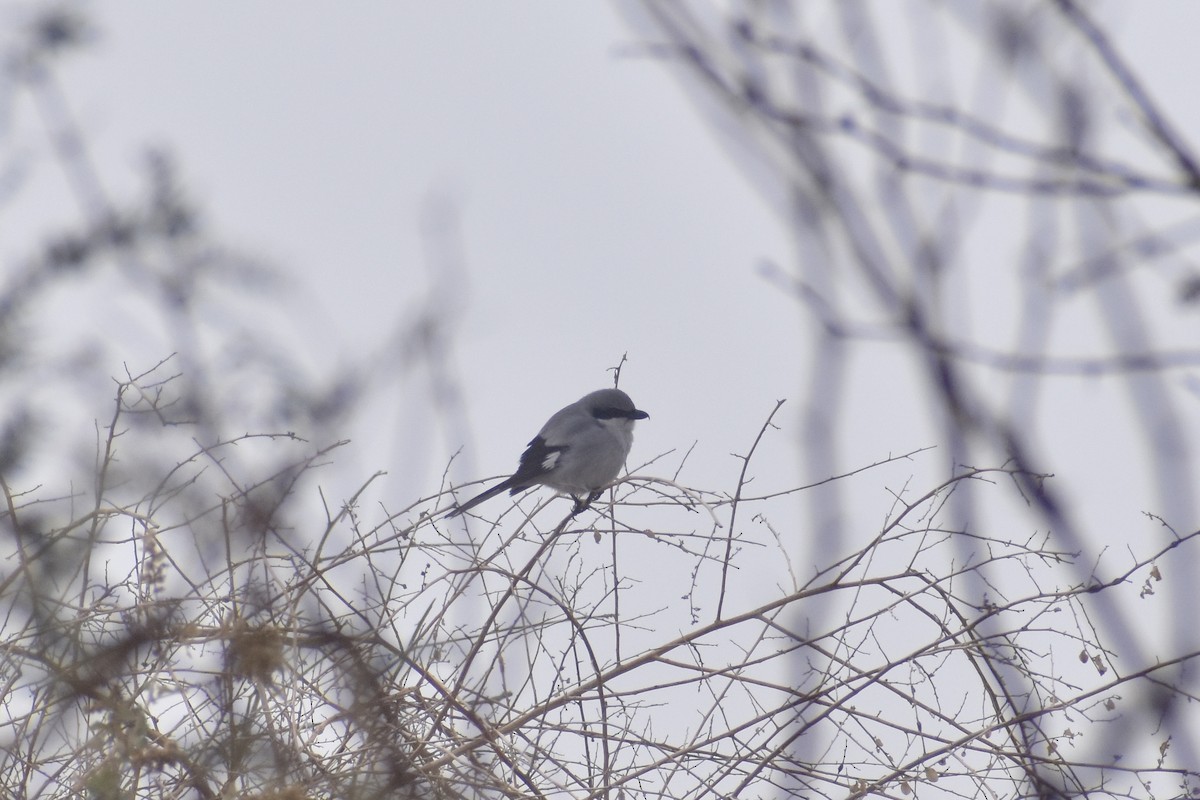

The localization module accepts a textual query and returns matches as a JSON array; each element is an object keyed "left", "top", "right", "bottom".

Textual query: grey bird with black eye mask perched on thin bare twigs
[{"left": 446, "top": 389, "right": 649, "bottom": 517}]
